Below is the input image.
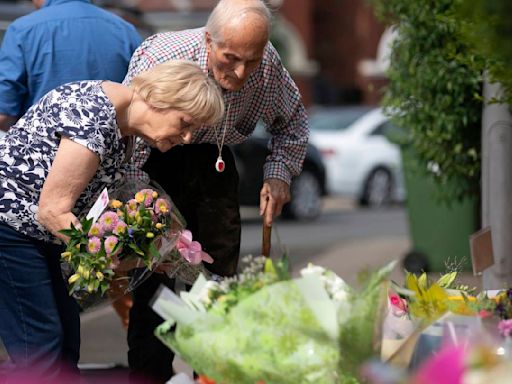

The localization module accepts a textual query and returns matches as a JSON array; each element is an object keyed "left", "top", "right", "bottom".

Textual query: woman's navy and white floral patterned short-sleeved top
[{"left": 0, "top": 80, "right": 125, "bottom": 242}]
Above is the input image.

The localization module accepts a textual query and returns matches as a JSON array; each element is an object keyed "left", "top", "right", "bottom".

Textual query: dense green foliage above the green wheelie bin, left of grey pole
[{"left": 369, "top": 0, "right": 484, "bottom": 201}]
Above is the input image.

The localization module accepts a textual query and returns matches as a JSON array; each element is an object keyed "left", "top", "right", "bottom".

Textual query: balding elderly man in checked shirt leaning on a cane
[{"left": 125, "top": 0, "right": 309, "bottom": 382}]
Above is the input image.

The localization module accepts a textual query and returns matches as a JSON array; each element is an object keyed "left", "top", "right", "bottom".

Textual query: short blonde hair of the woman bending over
[{"left": 131, "top": 60, "right": 224, "bottom": 125}]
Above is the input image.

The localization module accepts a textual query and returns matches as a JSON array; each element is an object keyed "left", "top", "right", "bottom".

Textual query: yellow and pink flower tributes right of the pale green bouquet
[{"left": 364, "top": 271, "right": 512, "bottom": 384}]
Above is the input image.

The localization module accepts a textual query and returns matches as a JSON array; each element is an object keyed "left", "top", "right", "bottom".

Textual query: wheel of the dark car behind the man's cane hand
[{"left": 283, "top": 171, "right": 322, "bottom": 221}]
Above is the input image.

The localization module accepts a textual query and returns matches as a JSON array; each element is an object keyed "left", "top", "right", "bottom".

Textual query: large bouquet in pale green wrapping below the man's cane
[{"left": 153, "top": 257, "right": 394, "bottom": 384}]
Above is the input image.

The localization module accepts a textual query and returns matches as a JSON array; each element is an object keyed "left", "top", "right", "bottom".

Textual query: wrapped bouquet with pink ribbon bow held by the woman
[{"left": 61, "top": 184, "right": 213, "bottom": 308}]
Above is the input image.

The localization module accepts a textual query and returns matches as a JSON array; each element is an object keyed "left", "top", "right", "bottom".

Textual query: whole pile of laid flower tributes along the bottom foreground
[{"left": 153, "top": 257, "right": 512, "bottom": 384}]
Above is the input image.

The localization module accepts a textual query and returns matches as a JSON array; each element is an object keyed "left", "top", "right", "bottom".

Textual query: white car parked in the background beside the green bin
[{"left": 310, "top": 107, "right": 405, "bottom": 207}]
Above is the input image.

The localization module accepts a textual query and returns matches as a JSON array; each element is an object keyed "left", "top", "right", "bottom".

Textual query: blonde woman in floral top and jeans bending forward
[{"left": 0, "top": 60, "right": 224, "bottom": 382}]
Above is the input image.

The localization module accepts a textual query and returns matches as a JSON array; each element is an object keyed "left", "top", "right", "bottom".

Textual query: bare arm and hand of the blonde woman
[{"left": 37, "top": 137, "right": 100, "bottom": 242}]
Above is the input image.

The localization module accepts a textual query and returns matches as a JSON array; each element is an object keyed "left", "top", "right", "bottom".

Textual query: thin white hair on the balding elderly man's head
[{"left": 206, "top": 0, "right": 272, "bottom": 43}]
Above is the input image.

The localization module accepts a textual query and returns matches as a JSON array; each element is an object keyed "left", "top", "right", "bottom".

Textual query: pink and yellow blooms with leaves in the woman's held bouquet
[{"left": 61, "top": 189, "right": 177, "bottom": 294}]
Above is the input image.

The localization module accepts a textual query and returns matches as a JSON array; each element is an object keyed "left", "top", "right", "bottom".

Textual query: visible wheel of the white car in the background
[{"left": 360, "top": 168, "right": 393, "bottom": 208}]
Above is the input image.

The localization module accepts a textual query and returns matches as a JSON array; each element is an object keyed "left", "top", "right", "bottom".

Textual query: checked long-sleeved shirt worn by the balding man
[{"left": 123, "top": 28, "right": 309, "bottom": 184}]
